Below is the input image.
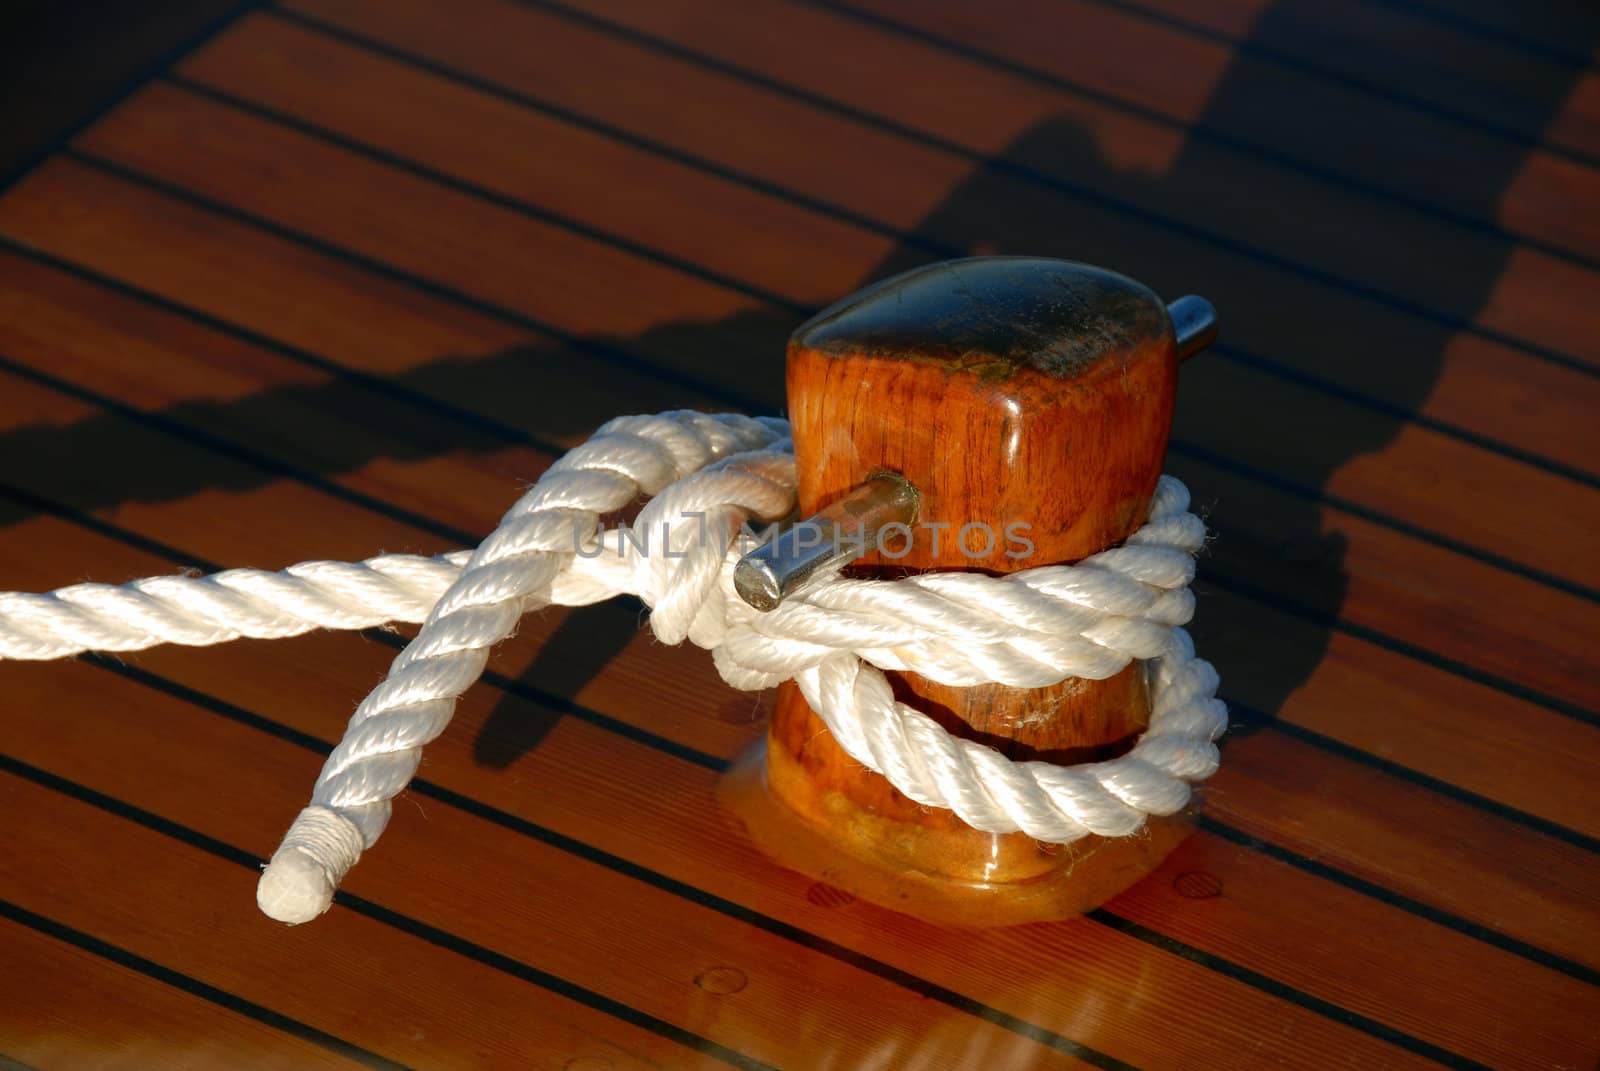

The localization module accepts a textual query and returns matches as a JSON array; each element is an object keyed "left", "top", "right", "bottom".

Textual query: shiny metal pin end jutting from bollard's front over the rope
[{"left": 733, "top": 472, "right": 922, "bottom": 612}]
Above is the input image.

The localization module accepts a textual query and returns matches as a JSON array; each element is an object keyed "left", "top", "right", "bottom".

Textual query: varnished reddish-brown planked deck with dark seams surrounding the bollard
[{"left": 0, "top": 0, "right": 1600, "bottom": 1069}]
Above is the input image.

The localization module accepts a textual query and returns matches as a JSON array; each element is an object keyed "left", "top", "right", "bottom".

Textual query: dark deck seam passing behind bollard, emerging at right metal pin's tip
[{"left": 246, "top": 8, "right": 1600, "bottom": 488}]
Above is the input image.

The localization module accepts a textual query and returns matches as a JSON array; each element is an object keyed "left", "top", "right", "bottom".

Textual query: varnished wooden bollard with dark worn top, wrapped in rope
[{"left": 726, "top": 256, "right": 1214, "bottom": 925}]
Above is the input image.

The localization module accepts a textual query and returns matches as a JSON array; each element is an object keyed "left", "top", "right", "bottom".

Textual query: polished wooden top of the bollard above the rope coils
[{"left": 789, "top": 256, "right": 1184, "bottom": 573}]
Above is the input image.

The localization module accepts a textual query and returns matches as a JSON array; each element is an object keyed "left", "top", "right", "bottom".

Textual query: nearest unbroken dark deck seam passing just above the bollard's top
[{"left": 517, "top": 0, "right": 1600, "bottom": 376}]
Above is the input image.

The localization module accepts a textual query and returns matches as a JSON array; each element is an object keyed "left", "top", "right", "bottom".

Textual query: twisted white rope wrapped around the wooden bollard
[{"left": 0, "top": 411, "right": 1227, "bottom": 922}]
